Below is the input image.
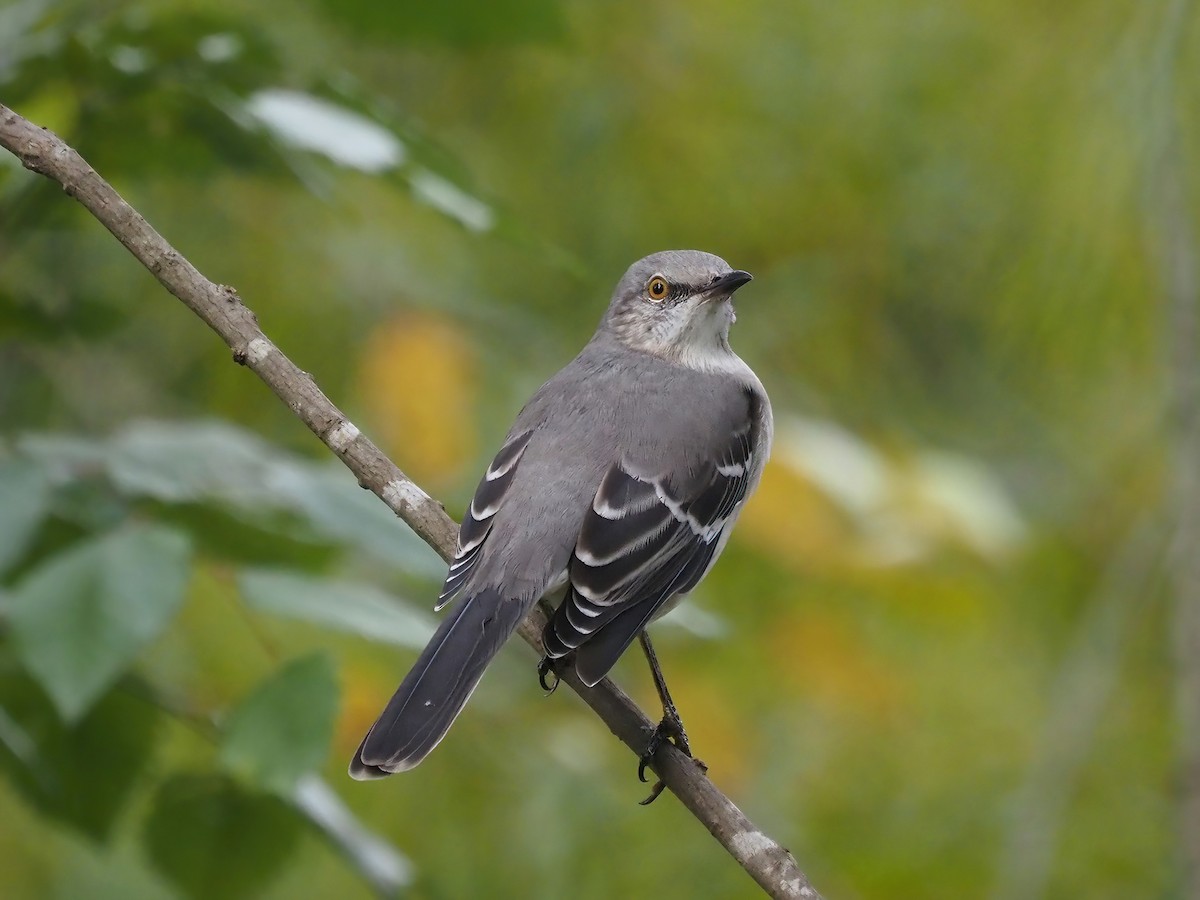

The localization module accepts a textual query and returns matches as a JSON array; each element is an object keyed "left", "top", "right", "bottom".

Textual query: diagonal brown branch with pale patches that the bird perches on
[{"left": 0, "top": 104, "right": 820, "bottom": 900}]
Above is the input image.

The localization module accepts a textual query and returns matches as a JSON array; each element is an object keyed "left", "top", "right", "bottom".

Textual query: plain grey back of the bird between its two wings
[{"left": 464, "top": 335, "right": 769, "bottom": 600}]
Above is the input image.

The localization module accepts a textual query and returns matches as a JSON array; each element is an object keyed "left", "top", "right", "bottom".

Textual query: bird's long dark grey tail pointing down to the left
[{"left": 350, "top": 588, "right": 524, "bottom": 781}]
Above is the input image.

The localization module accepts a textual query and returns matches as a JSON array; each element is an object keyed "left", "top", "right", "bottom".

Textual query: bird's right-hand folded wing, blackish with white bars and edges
[{"left": 545, "top": 401, "right": 757, "bottom": 684}]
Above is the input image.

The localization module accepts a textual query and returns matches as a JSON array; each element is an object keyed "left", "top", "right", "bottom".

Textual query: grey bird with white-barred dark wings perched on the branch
[{"left": 350, "top": 251, "right": 772, "bottom": 798}]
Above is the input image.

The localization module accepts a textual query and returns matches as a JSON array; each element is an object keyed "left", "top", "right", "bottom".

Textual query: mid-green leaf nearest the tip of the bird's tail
[{"left": 221, "top": 655, "right": 337, "bottom": 793}]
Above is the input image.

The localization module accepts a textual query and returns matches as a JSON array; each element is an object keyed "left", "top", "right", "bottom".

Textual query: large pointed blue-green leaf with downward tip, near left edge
[{"left": 8, "top": 526, "right": 191, "bottom": 721}]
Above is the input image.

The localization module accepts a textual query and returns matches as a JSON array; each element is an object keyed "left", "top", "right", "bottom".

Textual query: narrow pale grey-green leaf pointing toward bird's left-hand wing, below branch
[{"left": 238, "top": 569, "right": 434, "bottom": 649}]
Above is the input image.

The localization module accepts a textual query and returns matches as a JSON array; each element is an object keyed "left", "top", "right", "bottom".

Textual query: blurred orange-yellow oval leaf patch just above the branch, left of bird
[{"left": 359, "top": 312, "right": 476, "bottom": 487}]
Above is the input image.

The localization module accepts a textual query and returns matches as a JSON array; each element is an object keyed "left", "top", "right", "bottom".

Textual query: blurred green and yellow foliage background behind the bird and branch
[{"left": 0, "top": 0, "right": 1200, "bottom": 900}]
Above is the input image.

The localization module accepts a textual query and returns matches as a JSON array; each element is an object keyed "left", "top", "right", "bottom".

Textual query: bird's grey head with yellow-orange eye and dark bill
[{"left": 601, "top": 250, "right": 751, "bottom": 368}]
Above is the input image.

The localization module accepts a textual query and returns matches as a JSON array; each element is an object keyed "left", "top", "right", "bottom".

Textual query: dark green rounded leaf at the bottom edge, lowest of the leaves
[{"left": 144, "top": 775, "right": 304, "bottom": 900}]
